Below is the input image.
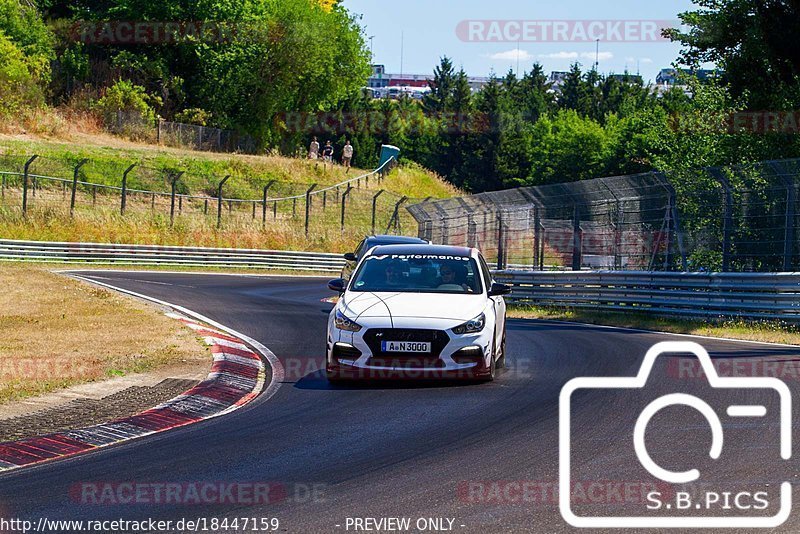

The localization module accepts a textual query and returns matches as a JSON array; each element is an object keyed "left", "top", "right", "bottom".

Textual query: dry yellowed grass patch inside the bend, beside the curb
[{"left": 0, "top": 264, "right": 208, "bottom": 402}]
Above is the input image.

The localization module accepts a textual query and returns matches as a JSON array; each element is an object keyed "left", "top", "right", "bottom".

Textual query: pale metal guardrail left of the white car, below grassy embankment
[{"left": 0, "top": 239, "right": 345, "bottom": 273}]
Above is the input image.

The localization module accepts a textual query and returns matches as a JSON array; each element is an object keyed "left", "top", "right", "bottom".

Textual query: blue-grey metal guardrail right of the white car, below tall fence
[{"left": 495, "top": 270, "right": 800, "bottom": 322}]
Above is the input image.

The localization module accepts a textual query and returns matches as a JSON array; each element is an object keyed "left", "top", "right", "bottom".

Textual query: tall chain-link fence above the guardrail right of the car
[{"left": 408, "top": 160, "right": 800, "bottom": 271}]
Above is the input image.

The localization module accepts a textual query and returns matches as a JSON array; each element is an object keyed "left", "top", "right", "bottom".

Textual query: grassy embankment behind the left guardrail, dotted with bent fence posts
[{"left": 0, "top": 135, "right": 458, "bottom": 252}]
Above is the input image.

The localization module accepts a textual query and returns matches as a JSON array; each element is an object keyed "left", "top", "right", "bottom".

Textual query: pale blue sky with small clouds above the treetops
[{"left": 343, "top": 0, "right": 693, "bottom": 81}]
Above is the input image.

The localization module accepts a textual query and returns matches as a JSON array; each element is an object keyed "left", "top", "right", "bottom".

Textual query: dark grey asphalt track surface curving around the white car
[{"left": 0, "top": 272, "right": 800, "bottom": 532}]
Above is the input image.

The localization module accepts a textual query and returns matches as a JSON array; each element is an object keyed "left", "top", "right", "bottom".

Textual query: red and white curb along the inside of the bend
[{"left": 0, "top": 277, "right": 283, "bottom": 472}]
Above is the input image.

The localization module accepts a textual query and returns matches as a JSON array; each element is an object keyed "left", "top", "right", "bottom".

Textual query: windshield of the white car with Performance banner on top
[{"left": 350, "top": 254, "right": 482, "bottom": 294}]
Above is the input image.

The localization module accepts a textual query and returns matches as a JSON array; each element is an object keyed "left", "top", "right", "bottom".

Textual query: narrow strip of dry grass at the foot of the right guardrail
[{"left": 508, "top": 306, "right": 800, "bottom": 345}]
